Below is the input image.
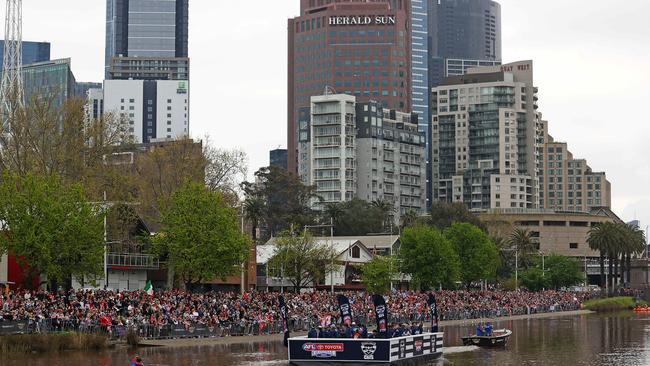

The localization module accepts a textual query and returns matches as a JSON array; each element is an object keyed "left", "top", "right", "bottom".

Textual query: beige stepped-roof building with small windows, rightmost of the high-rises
[{"left": 539, "top": 121, "right": 612, "bottom": 212}]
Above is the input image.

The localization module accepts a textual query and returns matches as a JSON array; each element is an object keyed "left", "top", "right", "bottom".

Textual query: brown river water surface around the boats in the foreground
[{"left": 0, "top": 313, "right": 650, "bottom": 366}]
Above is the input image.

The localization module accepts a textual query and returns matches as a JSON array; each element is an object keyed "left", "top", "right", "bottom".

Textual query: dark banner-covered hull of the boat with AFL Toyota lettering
[{"left": 289, "top": 333, "right": 443, "bottom": 366}]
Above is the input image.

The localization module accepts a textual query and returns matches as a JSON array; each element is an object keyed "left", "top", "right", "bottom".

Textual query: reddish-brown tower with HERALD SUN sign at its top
[{"left": 287, "top": 0, "right": 411, "bottom": 172}]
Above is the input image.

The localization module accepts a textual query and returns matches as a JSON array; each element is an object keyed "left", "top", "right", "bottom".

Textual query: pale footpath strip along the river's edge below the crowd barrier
[{"left": 140, "top": 310, "right": 594, "bottom": 347}]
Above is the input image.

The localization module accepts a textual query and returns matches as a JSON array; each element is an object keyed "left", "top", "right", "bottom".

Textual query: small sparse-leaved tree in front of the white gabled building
[{"left": 268, "top": 232, "right": 336, "bottom": 293}]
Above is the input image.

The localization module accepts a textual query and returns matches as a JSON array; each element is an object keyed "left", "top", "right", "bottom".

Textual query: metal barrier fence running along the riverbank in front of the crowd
[{"left": 0, "top": 305, "right": 579, "bottom": 340}]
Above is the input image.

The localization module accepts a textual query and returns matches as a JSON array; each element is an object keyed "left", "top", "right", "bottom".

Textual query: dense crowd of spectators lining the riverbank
[{"left": 0, "top": 290, "right": 589, "bottom": 338}]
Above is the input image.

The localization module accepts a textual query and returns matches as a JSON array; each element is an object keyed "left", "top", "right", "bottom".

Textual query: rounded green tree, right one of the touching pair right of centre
[{"left": 444, "top": 223, "right": 499, "bottom": 288}]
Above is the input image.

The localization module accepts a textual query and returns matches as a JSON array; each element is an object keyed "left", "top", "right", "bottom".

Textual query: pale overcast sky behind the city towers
[{"left": 19, "top": 0, "right": 650, "bottom": 229}]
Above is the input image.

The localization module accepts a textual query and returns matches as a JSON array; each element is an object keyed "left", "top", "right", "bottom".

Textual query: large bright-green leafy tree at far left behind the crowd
[{"left": 0, "top": 173, "right": 104, "bottom": 289}]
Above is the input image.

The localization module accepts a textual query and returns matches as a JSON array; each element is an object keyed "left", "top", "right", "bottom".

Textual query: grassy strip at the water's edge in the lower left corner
[{"left": 0, "top": 333, "right": 109, "bottom": 354}]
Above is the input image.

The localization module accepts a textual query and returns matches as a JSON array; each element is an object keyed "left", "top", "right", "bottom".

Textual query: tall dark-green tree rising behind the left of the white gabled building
[{"left": 242, "top": 167, "right": 318, "bottom": 238}]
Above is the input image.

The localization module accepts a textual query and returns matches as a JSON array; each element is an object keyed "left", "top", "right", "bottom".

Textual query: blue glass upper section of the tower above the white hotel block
[{"left": 105, "top": 0, "right": 189, "bottom": 79}]
